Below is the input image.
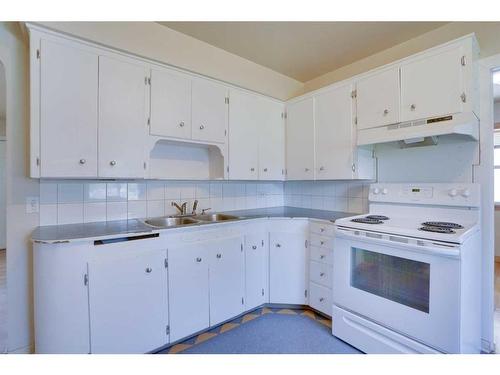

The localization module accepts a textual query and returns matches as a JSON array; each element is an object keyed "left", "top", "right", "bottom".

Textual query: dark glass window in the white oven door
[{"left": 351, "top": 247, "right": 430, "bottom": 313}]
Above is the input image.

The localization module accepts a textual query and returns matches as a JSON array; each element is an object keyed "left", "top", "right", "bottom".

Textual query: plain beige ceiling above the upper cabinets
[{"left": 159, "top": 22, "right": 445, "bottom": 82}]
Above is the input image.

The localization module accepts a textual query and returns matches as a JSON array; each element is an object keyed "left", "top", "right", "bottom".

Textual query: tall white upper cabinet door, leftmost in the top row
[{"left": 40, "top": 39, "right": 98, "bottom": 177}]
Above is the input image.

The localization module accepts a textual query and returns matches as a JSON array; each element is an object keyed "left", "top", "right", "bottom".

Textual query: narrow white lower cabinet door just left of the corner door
[{"left": 245, "top": 233, "right": 269, "bottom": 310}]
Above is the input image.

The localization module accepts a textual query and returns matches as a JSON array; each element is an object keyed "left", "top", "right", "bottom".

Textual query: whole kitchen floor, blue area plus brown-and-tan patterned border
[{"left": 162, "top": 308, "right": 361, "bottom": 354}]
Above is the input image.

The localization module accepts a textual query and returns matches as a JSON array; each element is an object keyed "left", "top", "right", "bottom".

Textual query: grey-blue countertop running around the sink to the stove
[{"left": 31, "top": 206, "right": 356, "bottom": 243}]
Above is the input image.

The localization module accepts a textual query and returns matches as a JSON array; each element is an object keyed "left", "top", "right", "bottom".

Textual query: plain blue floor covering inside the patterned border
[{"left": 182, "top": 314, "right": 361, "bottom": 354}]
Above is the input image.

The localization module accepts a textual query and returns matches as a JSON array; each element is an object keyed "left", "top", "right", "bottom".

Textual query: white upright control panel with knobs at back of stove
[{"left": 369, "top": 183, "right": 480, "bottom": 207}]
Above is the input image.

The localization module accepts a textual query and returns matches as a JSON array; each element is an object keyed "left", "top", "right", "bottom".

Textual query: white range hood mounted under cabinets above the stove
[{"left": 357, "top": 112, "right": 479, "bottom": 146}]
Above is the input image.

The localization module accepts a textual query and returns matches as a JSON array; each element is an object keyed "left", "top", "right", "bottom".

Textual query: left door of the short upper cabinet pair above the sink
[{"left": 150, "top": 68, "right": 191, "bottom": 139}]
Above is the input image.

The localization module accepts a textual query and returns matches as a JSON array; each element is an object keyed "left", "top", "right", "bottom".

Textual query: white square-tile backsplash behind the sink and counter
[{"left": 40, "top": 180, "right": 368, "bottom": 225}]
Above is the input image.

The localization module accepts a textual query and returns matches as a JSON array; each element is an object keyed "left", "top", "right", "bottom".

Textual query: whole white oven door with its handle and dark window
[{"left": 333, "top": 228, "right": 460, "bottom": 353}]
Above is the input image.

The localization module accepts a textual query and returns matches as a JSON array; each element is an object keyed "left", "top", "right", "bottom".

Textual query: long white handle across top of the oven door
[{"left": 335, "top": 227, "right": 460, "bottom": 258}]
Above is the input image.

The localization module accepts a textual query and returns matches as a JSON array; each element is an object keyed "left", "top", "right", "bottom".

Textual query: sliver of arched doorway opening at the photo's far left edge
[{"left": 0, "top": 58, "right": 7, "bottom": 353}]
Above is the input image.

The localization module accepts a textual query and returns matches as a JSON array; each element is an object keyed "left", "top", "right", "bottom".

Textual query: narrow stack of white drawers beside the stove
[{"left": 309, "top": 221, "right": 334, "bottom": 316}]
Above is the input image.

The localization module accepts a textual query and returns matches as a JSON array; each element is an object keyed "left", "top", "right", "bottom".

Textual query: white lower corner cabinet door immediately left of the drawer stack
[{"left": 269, "top": 232, "right": 309, "bottom": 304}]
